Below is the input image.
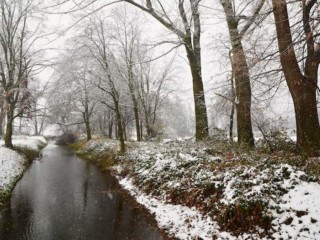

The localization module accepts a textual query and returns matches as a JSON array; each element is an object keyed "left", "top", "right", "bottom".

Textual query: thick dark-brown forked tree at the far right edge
[{"left": 272, "top": 0, "right": 320, "bottom": 155}]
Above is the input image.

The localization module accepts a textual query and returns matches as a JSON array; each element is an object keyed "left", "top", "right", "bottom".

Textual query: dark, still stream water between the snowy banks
[{"left": 0, "top": 144, "right": 162, "bottom": 240}]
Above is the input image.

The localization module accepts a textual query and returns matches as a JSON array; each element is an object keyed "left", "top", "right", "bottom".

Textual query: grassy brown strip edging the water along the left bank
[{"left": 0, "top": 142, "right": 48, "bottom": 212}]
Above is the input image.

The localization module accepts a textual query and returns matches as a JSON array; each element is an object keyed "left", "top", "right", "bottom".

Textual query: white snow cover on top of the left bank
[{"left": 0, "top": 136, "right": 46, "bottom": 191}]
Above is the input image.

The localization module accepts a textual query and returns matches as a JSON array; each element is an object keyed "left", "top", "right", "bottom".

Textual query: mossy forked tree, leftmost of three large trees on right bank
[{"left": 122, "top": 0, "right": 209, "bottom": 140}]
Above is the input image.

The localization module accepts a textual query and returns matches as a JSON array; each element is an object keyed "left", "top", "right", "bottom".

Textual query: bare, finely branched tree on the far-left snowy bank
[{"left": 0, "top": 0, "right": 35, "bottom": 148}]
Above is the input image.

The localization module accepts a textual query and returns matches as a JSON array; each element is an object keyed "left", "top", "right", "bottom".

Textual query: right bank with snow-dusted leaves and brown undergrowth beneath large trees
[{"left": 73, "top": 139, "right": 320, "bottom": 239}]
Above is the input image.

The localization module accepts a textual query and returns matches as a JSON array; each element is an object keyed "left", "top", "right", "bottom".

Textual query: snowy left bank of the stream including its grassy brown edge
[{"left": 0, "top": 136, "right": 47, "bottom": 210}]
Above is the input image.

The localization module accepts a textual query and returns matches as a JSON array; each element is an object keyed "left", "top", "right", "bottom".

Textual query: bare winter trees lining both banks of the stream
[{"left": 0, "top": 0, "right": 320, "bottom": 155}]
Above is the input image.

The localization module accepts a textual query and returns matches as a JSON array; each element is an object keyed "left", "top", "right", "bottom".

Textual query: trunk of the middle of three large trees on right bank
[{"left": 221, "top": 0, "right": 254, "bottom": 147}]
